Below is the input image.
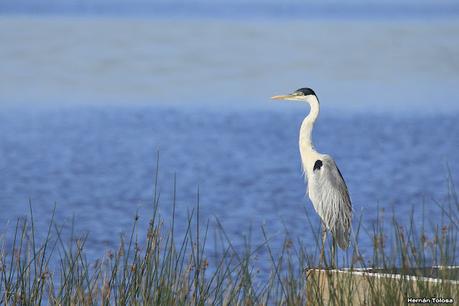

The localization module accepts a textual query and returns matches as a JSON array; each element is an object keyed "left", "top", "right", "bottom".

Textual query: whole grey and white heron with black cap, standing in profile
[{"left": 272, "top": 88, "right": 352, "bottom": 262}]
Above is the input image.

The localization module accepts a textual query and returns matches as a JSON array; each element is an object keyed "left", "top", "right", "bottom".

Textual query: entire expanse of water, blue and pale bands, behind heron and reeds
[{"left": 0, "top": 0, "right": 459, "bottom": 268}]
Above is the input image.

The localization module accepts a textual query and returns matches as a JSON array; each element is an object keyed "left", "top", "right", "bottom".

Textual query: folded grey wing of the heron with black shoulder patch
[{"left": 308, "top": 155, "right": 352, "bottom": 249}]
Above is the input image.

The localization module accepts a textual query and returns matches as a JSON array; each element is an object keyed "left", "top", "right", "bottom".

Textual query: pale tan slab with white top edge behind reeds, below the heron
[{"left": 306, "top": 267, "right": 459, "bottom": 305}]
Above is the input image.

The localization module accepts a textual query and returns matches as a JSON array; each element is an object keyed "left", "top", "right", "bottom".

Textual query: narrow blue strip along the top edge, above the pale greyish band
[{"left": 0, "top": 0, "right": 459, "bottom": 19}]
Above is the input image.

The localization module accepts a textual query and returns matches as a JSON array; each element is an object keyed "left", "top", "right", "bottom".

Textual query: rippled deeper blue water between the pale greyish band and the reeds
[{"left": 0, "top": 106, "right": 459, "bottom": 258}]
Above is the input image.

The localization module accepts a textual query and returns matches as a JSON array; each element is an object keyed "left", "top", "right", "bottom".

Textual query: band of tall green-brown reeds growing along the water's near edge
[{"left": 0, "top": 167, "right": 459, "bottom": 305}]
